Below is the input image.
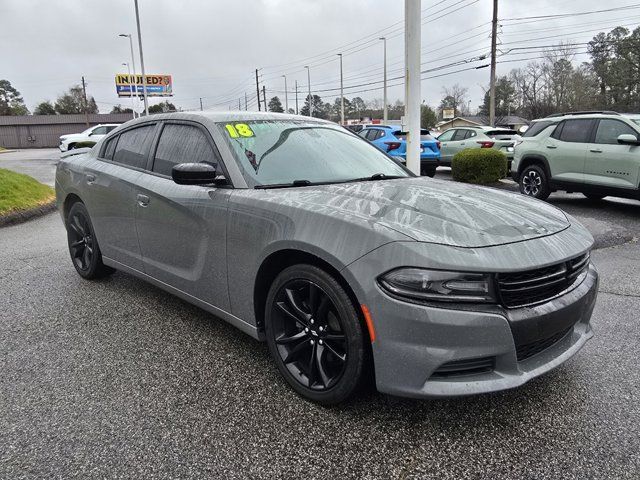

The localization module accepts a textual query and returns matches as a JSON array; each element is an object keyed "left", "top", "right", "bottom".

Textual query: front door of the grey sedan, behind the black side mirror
[{"left": 135, "top": 121, "right": 233, "bottom": 310}]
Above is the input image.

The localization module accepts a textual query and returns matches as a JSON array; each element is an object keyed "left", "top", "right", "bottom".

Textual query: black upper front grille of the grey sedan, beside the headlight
[{"left": 496, "top": 253, "right": 589, "bottom": 308}]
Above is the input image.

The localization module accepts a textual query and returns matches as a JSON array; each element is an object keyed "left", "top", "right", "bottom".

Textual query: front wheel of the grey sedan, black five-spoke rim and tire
[{"left": 265, "top": 264, "right": 368, "bottom": 405}]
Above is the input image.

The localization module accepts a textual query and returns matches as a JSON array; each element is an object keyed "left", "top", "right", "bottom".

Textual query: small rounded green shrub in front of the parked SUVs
[{"left": 451, "top": 148, "right": 507, "bottom": 184}]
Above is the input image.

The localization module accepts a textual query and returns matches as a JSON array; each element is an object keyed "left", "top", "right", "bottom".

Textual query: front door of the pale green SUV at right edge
[{"left": 584, "top": 118, "right": 640, "bottom": 189}]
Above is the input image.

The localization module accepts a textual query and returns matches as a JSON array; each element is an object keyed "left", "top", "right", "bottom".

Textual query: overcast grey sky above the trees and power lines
[{"left": 0, "top": 0, "right": 640, "bottom": 112}]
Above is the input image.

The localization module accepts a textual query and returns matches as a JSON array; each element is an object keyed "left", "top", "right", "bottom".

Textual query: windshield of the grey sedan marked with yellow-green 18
[{"left": 217, "top": 120, "right": 411, "bottom": 187}]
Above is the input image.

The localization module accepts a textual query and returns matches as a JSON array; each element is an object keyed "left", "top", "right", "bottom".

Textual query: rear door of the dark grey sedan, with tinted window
[{"left": 82, "top": 123, "right": 157, "bottom": 271}]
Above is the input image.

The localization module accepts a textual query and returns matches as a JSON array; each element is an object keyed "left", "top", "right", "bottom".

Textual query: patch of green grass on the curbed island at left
[{"left": 0, "top": 168, "right": 55, "bottom": 215}]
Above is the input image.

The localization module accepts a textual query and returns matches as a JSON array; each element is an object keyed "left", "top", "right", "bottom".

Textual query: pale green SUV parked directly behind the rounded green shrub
[{"left": 438, "top": 127, "right": 520, "bottom": 167}]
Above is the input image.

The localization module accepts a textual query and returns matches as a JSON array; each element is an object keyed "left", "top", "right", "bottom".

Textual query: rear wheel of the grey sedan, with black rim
[{"left": 66, "top": 202, "right": 115, "bottom": 280}]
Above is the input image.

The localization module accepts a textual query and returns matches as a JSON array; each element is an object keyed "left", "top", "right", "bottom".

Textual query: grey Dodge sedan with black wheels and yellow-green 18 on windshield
[{"left": 56, "top": 112, "right": 598, "bottom": 404}]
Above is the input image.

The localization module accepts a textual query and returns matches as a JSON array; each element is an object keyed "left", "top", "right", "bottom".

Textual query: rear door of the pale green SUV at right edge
[{"left": 544, "top": 118, "right": 595, "bottom": 184}]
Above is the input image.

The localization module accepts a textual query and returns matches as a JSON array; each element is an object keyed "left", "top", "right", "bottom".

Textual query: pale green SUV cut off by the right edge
[{"left": 511, "top": 112, "right": 640, "bottom": 200}]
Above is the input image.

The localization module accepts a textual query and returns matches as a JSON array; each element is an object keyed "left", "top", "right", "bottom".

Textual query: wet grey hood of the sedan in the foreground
[{"left": 281, "top": 177, "right": 570, "bottom": 248}]
